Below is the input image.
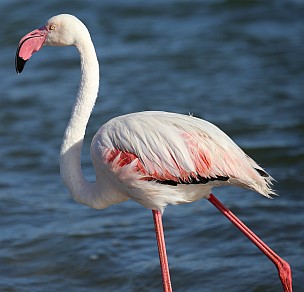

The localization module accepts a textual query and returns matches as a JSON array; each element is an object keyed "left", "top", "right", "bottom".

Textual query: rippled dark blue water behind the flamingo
[{"left": 0, "top": 0, "right": 304, "bottom": 292}]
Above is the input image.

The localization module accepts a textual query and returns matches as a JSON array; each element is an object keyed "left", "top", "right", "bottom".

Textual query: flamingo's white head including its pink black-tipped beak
[{"left": 15, "top": 14, "right": 90, "bottom": 74}]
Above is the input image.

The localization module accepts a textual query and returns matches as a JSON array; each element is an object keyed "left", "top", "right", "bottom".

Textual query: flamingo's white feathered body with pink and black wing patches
[{"left": 91, "top": 111, "right": 274, "bottom": 212}]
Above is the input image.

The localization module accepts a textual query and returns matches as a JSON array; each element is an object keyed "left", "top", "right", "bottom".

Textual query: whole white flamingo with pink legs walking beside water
[{"left": 15, "top": 14, "right": 292, "bottom": 292}]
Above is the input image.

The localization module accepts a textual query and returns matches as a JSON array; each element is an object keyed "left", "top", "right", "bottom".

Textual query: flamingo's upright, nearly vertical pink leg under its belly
[{"left": 152, "top": 210, "right": 172, "bottom": 292}]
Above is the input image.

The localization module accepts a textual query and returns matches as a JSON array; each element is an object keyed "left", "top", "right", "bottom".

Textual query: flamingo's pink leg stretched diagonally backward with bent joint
[{"left": 209, "top": 194, "right": 292, "bottom": 292}]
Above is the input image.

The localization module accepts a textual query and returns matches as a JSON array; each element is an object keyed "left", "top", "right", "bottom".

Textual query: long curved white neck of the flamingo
[{"left": 60, "top": 37, "right": 99, "bottom": 205}]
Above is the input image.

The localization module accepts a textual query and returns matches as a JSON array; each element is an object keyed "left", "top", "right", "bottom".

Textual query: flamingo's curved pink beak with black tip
[{"left": 15, "top": 26, "right": 48, "bottom": 74}]
